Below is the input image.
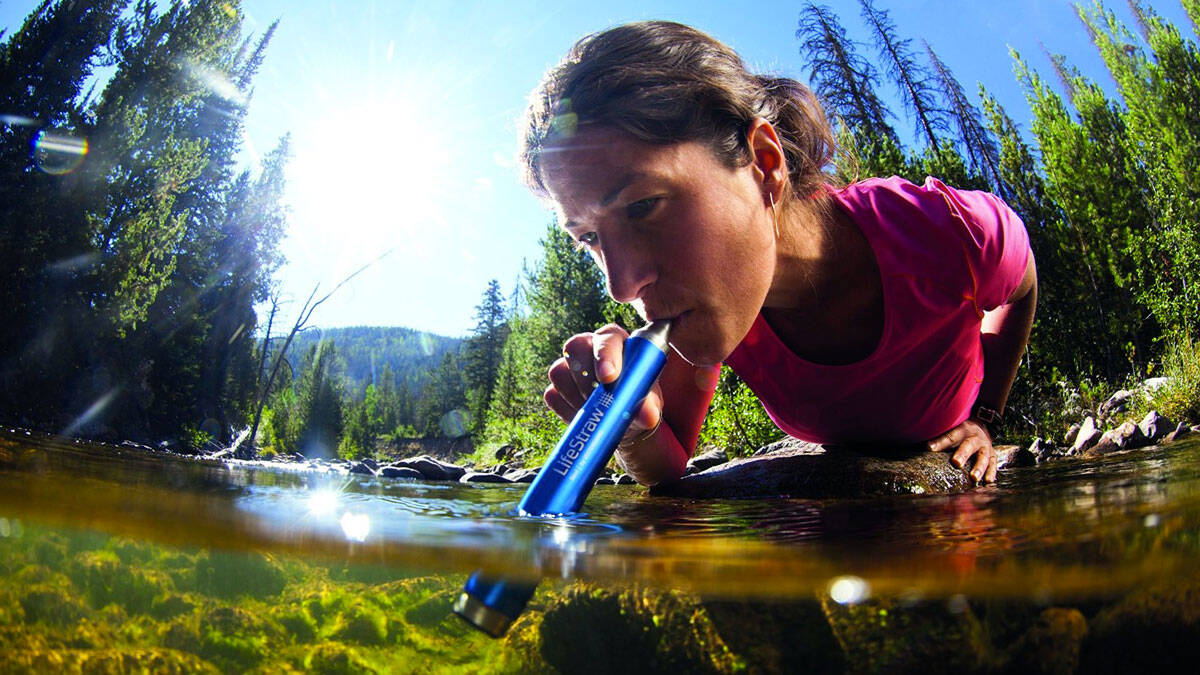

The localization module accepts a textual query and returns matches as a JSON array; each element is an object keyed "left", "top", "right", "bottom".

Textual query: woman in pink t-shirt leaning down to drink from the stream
[{"left": 523, "top": 22, "right": 1037, "bottom": 485}]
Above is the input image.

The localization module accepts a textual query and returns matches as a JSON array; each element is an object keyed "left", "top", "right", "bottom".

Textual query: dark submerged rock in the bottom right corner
[{"left": 1079, "top": 580, "right": 1200, "bottom": 673}]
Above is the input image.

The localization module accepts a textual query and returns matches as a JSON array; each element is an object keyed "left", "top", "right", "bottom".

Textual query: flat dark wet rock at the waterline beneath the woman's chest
[{"left": 650, "top": 438, "right": 1016, "bottom": 498}]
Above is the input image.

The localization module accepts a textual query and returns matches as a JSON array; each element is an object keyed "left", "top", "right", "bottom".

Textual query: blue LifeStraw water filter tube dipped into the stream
[{"left": 454, "top": 321, "right": 671, "bottom": 638}]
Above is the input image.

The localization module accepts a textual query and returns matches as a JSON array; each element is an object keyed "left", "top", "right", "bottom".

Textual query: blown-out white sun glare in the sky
[{"left": 288, "top": 100, "right": 449, "bottom": 275}]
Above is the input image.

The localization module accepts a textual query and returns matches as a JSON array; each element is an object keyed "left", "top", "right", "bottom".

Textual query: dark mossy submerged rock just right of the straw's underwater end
[{"left": 538, "top": 584, "right": 737, "bottom": 673}]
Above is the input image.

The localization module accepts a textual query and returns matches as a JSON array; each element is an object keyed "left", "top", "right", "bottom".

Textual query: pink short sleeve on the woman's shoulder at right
[{"left": 925, "top": 178, "right": 1031, "bottom": 312}]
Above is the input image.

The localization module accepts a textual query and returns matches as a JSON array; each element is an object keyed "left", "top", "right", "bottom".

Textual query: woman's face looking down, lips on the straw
[{"left": 542, "top": 127, "right": 775, "bottom": 365}]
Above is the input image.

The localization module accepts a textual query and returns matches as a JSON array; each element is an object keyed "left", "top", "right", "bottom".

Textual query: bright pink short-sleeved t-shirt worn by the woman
[{"left": 726, "top": 178, "right": 1030, "bottom": 443}]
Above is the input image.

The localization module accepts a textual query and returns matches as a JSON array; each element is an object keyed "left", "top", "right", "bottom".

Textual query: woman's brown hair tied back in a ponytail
[{"left": 521, "top": 22, "right": 834, "bottom": 197}]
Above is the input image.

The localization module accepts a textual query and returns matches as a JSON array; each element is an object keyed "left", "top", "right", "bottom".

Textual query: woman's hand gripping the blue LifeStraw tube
[{"left": 542, "top": 323, "right": 662, "bottom": 440}]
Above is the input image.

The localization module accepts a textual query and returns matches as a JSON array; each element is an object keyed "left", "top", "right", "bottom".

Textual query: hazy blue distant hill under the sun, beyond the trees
[{"left": 288, "top": 325, "right": 463, "bottom": 393}]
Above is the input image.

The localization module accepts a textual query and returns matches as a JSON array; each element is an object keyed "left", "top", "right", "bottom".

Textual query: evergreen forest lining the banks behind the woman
[{"left": 0, "top": 0, "right": 1200, "bottom": 459}]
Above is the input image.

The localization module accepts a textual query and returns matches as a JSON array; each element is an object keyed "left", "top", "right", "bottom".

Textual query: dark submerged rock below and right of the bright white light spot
[{"left": 821, "top": 596, "right": 994, "bottom": 673}]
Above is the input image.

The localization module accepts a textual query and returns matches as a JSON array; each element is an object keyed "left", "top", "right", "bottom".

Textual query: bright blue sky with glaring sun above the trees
[{"left": 0, "top": 0, "right": 1190, "bottom": 336}]
